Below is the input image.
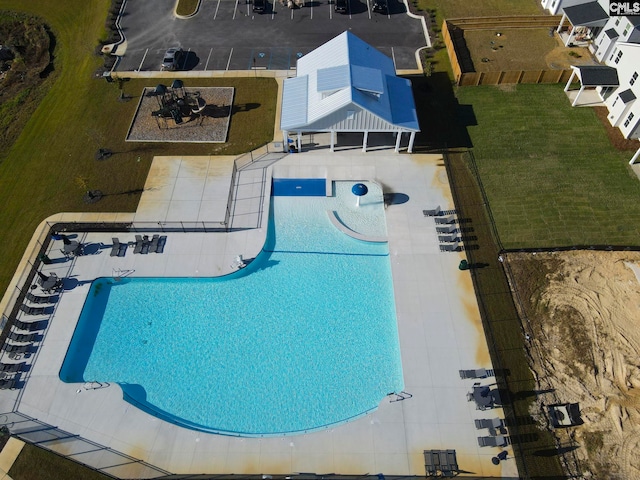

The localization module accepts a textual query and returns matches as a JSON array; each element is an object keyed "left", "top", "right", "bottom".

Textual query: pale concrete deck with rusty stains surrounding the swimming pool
[{"left": 0, "top": 149, "right": 518, "bottom": 478}]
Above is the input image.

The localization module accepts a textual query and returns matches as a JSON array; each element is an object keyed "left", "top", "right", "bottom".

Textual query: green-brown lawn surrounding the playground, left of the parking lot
[{"left": 0, "top": 0, "right": 277, "bottom": 292}]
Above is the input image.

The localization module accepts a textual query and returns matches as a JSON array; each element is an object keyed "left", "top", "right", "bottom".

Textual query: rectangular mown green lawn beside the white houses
[{"left": 457, "top": 85, "right": 640, "bottom": 248}]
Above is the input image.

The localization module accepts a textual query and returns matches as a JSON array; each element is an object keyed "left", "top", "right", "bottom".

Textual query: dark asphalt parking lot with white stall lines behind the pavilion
[{"left": 117, "top": 0, "right": 427, "bottom": 72}]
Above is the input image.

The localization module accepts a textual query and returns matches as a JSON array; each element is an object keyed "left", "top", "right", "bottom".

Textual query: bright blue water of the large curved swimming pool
[{"left": 60, "top": 182, "right": 404, "bottom": 436}]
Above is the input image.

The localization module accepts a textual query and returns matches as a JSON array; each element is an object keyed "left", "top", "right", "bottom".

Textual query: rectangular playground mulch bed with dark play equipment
[{"left": 127, "top": 87, "right": 234, "bottom": 143}]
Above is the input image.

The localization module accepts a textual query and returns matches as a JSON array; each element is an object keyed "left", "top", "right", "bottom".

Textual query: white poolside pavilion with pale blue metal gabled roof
[{"left": 280, "top": 32, "right": 420, "bottom": 152}]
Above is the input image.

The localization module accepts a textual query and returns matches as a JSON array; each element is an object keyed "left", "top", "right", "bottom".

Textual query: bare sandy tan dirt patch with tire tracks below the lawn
[{"left": 504, "top": 251, "right": 640, "bottom": 480}]
